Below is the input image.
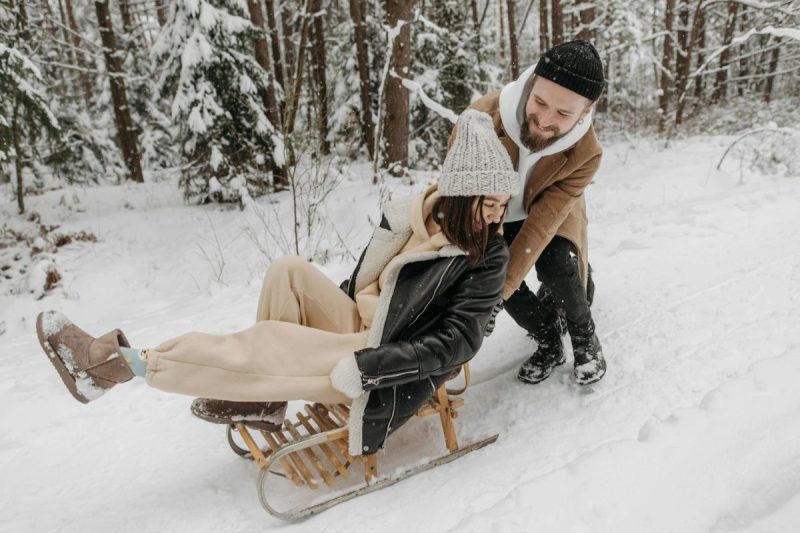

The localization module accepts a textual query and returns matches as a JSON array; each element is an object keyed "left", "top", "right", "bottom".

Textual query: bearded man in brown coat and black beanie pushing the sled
[{"left": 451, "top": 40, "right": 606, "bottom": 385}]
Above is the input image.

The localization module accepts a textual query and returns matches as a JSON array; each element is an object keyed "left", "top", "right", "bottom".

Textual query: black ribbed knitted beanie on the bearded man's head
[{"left": 533, "top": 40, "right": 605, "bottom": 102}]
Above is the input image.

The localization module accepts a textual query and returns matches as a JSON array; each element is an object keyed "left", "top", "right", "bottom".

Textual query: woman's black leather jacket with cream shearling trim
[{"left": 342, "top": 212, "right": 508, "bottom": 454}]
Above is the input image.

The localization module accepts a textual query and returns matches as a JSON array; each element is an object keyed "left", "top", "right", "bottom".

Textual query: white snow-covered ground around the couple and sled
[{"left": 0, "top": 138, "right": 800, "bottom": 533}]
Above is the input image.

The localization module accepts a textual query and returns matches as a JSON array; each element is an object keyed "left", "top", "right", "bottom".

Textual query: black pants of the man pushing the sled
[{"left": 503, "top": 220, "right": 594, "bottom": 333}]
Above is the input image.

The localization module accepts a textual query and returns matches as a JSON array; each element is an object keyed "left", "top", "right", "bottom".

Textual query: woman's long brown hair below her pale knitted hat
[{"left": 433, "top": 196, "right": 502, "bottom": 264}]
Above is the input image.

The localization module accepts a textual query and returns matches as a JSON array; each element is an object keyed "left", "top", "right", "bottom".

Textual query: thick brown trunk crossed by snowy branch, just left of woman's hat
[{"left": 385, "top": 0, "right": 414, "bottom": 175}]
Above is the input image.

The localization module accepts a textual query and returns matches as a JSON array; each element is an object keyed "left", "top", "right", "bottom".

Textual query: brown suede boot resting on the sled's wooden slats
[{"left": 192, "top": 398, "right": 288, "bottom": 431}]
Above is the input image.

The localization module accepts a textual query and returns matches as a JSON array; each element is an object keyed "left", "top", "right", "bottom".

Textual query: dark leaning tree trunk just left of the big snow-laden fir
[{"left": 94, "top": 0, "right": 144, "bottom": 182}]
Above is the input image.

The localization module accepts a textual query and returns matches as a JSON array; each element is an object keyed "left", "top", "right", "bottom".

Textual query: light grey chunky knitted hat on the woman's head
[{"left": 439, "top": 109, "right": 519, "bottom": 196}]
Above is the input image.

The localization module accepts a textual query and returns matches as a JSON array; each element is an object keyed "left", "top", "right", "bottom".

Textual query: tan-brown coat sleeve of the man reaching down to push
[{"left": 503, "top": 154, "right": 601, "bottom": 300}]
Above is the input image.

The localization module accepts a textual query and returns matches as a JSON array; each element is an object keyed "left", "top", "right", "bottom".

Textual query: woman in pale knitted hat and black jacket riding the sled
[{"left": 32, "top": 111, "right": 518, "bottom": 455}]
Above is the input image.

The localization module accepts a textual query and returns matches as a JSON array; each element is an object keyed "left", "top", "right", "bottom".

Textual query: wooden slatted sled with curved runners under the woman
[{"left": 222, "top": 365, "right": 497, "bottom": 521}]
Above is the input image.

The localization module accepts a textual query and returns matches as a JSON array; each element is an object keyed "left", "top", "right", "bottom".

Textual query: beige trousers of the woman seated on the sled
[{"left": 147, "top": 256, "right": 368, "bottom": 403}]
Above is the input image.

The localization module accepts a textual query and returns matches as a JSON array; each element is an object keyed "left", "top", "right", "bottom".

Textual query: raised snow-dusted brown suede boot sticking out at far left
[{"left": 36, "top": 311, "right": 134, "bottom": 403}]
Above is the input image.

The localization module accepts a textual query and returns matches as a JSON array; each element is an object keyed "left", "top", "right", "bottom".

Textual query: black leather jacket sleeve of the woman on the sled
[{"left": 355, "top": 238, "right": 508, "bottom": 390}]
